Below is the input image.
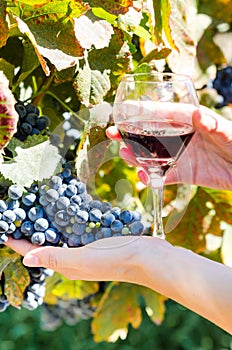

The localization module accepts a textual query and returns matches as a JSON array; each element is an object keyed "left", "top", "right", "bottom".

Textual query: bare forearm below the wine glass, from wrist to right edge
[{"left": 129, "top": 238, "right": 232, "bottom": 333}]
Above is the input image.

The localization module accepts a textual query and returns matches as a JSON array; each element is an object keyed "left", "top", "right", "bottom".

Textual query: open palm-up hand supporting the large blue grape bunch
[{"left": 6, "top": 236, "right": 157, "bottom": 282}]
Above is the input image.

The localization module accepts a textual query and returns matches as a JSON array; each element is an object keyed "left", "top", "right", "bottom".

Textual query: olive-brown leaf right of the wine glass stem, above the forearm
[{"left": 164, "top": 188, "right": 211, "bottom": 253}]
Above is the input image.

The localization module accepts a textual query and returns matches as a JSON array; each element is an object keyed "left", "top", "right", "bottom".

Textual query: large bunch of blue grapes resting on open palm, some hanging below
[{"left": 0, "top": 164, "right": 144, "bottom": 310}]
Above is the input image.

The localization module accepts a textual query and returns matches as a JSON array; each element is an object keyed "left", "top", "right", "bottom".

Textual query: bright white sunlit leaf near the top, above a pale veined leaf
[{"left": 74, "top": 15, "right": 114, "bottom": 49}]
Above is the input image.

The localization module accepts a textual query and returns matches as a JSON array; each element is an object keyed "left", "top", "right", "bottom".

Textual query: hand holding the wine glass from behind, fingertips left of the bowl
[{"left": 107, "top": 104, "right": 232, "bottom": 190}]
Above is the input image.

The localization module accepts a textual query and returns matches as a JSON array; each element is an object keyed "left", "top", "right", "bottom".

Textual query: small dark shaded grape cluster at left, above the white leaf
[{"left": 14, "top": 101, "right": 50, "bottom": 141}]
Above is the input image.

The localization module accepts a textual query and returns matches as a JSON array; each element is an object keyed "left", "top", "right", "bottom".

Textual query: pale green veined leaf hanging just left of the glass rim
[{"left": 73, "top": 64, "right": 110, "bottom": 107}]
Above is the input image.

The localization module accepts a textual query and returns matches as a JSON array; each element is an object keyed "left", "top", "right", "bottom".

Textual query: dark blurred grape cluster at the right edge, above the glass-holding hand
[{"left": 213, "top": 66, "right": 232, "bottom": 108}]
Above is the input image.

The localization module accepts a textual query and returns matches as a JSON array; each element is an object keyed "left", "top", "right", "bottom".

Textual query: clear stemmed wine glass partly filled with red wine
[{"left": 113, "top": 71, "right": 199, "bottom": 238}]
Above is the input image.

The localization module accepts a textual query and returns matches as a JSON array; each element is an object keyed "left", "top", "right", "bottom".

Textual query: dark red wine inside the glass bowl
[{"left": 118, "top": 118, "right": 194, "bottom": 170}]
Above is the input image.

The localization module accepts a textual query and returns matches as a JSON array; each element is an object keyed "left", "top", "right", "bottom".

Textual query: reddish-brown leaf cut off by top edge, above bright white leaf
[{"left": 88, "top": 0, "right": 133, "bottom": 16}]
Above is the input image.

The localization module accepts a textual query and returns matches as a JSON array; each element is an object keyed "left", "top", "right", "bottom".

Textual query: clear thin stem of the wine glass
[{"left": 149, "top": 168, "right": 165, "bottom": 238}]
